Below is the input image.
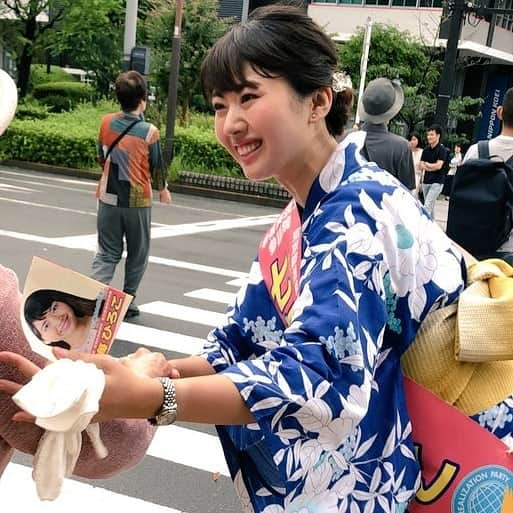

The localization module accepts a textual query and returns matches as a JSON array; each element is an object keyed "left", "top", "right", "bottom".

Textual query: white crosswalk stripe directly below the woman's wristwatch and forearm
[{"left": 148, "top": 425, "right": 230, "bottom": 476}]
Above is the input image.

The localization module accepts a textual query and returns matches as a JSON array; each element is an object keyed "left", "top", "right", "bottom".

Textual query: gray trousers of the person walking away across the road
[{"left": 91, "top": 201, "right": 151, "bottom": 297}]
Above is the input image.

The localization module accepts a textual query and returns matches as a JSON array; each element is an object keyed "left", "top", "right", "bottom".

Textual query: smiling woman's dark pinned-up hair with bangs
[{"left": 201, "top": 5, "right": 353, "bottom": 136}]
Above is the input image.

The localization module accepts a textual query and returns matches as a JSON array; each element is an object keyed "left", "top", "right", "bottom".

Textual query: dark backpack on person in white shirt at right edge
[{"left": 447, "top": 141, "right": 513, "bottom": 258}]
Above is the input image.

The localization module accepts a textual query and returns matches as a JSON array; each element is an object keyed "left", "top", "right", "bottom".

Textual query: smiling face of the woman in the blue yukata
[{"left": 212, "top": 66, "right": 311, "bottom": 180}]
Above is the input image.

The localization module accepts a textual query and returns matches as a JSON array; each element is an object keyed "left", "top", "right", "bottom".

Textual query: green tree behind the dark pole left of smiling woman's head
[{"left": 145, "top": 0, "right": 231, "bottom": 126}]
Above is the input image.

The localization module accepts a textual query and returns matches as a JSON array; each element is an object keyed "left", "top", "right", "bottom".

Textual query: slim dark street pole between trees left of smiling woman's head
[{"left": 163, "top": 0, "right": 184, "bottom": 169}]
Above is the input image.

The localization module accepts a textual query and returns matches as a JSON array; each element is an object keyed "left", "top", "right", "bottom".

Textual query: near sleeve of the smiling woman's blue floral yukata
[{"left": 208, "top": 196, "right": 386, "bottom": 447}]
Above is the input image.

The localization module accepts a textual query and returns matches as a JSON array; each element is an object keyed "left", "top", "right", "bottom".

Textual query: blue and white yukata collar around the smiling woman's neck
[{"left": 301, "top": 130, "right": 367, "bottom": 222}]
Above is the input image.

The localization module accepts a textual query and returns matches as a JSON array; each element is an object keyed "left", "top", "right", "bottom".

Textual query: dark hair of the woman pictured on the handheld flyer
[{"left": 23, "top": 289, "right": 96, "bottom": 347}]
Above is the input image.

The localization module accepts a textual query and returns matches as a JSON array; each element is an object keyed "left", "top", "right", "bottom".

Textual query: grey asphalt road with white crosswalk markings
[{"left": 0, "top": 166, "right": 278, "bottom": 513}]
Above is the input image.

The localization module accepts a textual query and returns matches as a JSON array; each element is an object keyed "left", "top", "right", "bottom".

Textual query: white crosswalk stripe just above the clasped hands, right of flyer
[{"left": 116, "top": 322, "right": 205, "bottom": 355}]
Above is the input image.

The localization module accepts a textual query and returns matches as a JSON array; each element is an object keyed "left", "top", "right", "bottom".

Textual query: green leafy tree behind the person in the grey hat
[{"left": 338, "top": 24, "right": 481, "bottom": 140}]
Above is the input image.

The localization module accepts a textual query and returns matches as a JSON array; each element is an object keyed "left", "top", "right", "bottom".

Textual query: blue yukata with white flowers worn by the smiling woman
[{"left": 202, "top": 132, "right": 465, "bottom": 513}]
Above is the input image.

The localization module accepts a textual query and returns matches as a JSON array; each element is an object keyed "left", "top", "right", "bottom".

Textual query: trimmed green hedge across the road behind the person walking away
[{"left": 0, "top": 104, "right": 242, "bottom": 176}]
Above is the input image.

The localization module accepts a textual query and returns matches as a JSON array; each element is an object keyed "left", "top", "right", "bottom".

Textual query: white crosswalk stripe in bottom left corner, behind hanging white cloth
[{"left": 0, "top": 463, "right": 183, "bottom": 513}]
